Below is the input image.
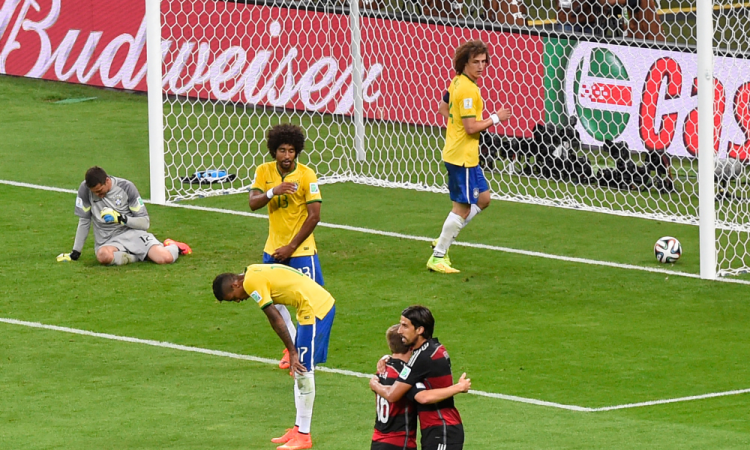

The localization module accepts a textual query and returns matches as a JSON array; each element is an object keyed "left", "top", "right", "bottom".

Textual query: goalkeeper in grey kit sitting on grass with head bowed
[{"left": 57, "top": 166, "right": 192, "bottom": 266}]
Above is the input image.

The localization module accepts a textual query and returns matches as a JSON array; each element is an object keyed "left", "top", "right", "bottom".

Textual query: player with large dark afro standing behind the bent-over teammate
[{"left": 249, "top": 124, "right": 324, "bottom": 369}]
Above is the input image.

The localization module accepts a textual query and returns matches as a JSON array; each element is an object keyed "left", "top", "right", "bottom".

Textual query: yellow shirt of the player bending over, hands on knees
[{"left": 242, "top": 264, "right": 336, "bottom": 325}]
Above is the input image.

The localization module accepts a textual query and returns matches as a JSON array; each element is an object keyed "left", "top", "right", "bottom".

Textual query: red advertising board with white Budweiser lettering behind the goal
[{"left": 0, "top": 0, "right": 544, "bottom": 135}]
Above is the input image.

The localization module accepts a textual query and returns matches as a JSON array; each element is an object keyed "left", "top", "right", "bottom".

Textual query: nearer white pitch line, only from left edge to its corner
[{"left": 0, "top": 318, "right": 592, "bottom": 411}]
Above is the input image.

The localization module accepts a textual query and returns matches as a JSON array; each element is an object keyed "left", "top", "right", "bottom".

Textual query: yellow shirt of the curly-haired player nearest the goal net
[{"left": 443, "top": 74, "right": 484, "bottom": 167}]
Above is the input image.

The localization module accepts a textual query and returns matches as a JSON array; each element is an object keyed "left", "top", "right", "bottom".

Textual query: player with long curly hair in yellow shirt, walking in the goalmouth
[{"left": 427, "top": 41, "right": 510, "bottom": 273}]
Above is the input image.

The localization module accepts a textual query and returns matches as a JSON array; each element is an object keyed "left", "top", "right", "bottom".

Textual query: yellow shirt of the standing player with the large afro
[{"left": 251, "top": 161, "right": 323, "bottom": 258}]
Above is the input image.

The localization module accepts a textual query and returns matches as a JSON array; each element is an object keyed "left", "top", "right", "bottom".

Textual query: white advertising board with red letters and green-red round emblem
[{"left": 565, "top": 42, "right": 750, "bottom": 160}]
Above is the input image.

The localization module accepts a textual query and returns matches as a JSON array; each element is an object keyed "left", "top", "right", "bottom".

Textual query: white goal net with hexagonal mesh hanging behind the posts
[{"left": 161, "top": 0, "right": 750, "bottom": 274}]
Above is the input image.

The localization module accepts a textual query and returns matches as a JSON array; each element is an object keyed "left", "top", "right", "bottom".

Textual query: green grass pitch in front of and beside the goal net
[{"left": 0, "top": 77, "right": 750, "bottom": 450}]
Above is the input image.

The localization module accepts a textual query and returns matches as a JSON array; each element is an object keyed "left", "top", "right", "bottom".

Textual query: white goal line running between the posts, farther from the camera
[{"left": 0, "top": 180, "right": 750, "bottom": 285}]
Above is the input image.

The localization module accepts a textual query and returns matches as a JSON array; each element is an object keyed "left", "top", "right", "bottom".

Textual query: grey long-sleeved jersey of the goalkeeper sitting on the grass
[{"left": 76, "top": 177, "right": 148, "bottom": 248}]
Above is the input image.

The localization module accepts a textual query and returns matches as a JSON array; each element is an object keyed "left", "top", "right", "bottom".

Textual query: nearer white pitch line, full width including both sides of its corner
[{"left": 0, "top": 318, "right": 750, "bottom": 412}]
